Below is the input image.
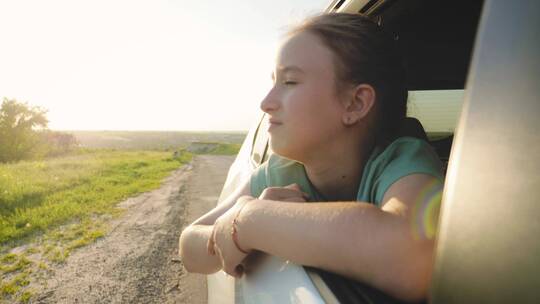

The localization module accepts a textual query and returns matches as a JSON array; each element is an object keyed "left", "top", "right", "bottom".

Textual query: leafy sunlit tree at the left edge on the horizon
[{"left": 0, "top": 98, "right": 49, "bottom": 162}]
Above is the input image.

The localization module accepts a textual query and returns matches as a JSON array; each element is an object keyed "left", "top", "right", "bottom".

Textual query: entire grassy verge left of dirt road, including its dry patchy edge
[{"left": 0, "top": 150, "right": 192, "bottom": 303}]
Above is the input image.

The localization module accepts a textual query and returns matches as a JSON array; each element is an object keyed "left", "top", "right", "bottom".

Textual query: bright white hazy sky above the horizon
[{"left": 0, "top": 0, "right": 330, "bottom": 131}]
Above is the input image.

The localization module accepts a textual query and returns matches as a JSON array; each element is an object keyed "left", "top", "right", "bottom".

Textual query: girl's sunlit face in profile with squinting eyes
[{"left": 261, "top": 32, "right": 344, "bottom": 161}]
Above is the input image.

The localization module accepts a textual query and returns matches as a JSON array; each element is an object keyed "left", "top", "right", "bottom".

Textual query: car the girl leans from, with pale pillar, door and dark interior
[{"left": 208, "top": 0, "right": 540, "bottom": 303}]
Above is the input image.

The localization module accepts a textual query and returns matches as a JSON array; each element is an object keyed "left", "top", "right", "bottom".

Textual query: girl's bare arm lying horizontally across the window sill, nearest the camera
[{"left": 239, "top": 200, "right": 432, "bottom": 300}]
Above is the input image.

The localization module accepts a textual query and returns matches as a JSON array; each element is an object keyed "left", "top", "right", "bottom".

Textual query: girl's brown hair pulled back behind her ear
[{"left": 288, "top": 13, "right": 407, "bottom": 144}]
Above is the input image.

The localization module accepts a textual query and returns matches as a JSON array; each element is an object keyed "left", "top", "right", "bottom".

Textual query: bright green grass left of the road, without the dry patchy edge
[{"left": 0, "top": 151, "right": 190, "bottom": 245}]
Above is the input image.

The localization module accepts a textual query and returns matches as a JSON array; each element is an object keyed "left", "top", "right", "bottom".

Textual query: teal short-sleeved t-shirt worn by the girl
[{"left": 251, "top": 137, "right": 444, "bottom": 206}]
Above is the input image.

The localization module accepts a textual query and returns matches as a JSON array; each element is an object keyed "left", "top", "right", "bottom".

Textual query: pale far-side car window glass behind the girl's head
[{"left": 407, "top": 90, "right": 464, "bottom": 139}]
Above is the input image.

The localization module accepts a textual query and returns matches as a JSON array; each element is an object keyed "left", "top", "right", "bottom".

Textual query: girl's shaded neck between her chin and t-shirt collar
[{"left": 304, "top": 132, "right": 372, "bottom": 201}]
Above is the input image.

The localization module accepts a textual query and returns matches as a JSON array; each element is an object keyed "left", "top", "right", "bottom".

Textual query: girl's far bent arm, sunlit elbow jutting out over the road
[{"left": 179, "top": 179, "right": 251, "bottom": 274}]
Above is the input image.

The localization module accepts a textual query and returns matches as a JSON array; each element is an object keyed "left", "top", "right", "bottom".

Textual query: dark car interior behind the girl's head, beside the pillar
[{"left": 374, "top": 0, "right": 483, "bottom": 173}]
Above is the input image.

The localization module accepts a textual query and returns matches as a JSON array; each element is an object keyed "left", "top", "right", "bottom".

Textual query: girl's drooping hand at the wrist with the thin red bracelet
[{"left": 207, "top": 196, "right": 253, "bottom": 278}]
